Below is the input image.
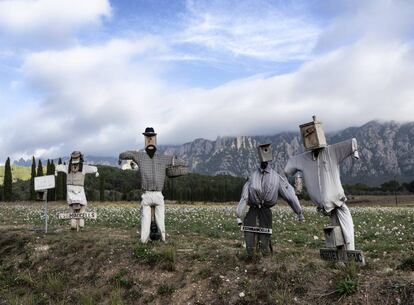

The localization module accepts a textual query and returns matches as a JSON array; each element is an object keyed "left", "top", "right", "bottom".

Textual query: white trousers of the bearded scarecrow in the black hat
[{"left": 141, "top": 191, "right": 165, "bottom": 244}]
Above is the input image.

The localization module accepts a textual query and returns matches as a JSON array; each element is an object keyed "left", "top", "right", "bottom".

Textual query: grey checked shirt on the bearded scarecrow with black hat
[{"left": 119, "top": 151, "right": 183, "bottom": 192}]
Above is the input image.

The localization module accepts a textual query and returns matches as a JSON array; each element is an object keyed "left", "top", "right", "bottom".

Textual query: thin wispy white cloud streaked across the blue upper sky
[{"left": 174, "top": 1, "right": 320, "bottom": 61}]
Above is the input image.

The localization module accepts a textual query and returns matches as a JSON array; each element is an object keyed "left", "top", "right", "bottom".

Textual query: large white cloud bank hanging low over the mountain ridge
[{"left": 0, "top": 2, "right": 414, "bottom": 160}]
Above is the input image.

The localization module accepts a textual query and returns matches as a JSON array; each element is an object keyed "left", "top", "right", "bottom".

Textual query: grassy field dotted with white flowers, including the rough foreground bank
[{"left": 0, "top": 203, "right": 414, "bottom": 305}]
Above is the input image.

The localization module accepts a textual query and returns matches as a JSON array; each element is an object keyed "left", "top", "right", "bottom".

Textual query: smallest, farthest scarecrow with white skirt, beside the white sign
[{"left": 55, "top": 151, "right": 99, "bottom": 230}]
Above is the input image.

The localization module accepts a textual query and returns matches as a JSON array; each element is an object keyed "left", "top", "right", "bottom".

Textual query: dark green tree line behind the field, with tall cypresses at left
[{"left": 0, "top": 157, "right": 414, "bottom": 202}]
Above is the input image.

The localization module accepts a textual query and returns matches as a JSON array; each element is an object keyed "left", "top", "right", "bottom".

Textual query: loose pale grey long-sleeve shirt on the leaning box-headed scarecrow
[{"left": 285, "top": 138, "right": 358, "bottom": 212}]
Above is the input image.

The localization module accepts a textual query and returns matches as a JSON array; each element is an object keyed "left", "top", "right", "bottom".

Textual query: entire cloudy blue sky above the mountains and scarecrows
[{"left": 0, "top": 0, "right": 414, "bottom": 163}]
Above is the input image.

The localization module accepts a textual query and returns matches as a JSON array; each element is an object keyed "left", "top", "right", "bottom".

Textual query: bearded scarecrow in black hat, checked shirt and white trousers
[{"left": 119, "top": 127, "right": 188, "bottom": 243}]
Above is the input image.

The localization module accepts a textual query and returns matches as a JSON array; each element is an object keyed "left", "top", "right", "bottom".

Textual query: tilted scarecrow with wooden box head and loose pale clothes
[{"left": 285, "top": 116, "right": 359, "bottom": 250}]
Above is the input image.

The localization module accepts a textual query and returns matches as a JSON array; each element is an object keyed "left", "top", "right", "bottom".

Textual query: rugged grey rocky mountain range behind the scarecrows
[{"left": 15, "top": 121, "right": 414, "bottom": 185}]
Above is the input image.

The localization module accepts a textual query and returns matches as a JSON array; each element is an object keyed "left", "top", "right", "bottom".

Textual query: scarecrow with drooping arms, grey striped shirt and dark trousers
[{"left": 236, "top": 144, "right": 304, "bottom": 257}]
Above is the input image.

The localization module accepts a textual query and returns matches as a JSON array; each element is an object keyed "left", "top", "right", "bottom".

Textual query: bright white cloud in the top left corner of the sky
[{"left": 0, "top": 0, "right": 111, "bottom": 46}]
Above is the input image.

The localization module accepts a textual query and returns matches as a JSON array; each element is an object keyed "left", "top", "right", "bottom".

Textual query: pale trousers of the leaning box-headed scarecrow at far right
[{"left": 331, "top": 203, "right": 355, "bottom": 250}]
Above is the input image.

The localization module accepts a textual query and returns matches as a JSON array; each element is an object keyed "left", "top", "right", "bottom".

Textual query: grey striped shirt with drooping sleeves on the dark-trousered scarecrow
[{"left": 236, "top": 165, "right": 302, "bottom": 218}]
